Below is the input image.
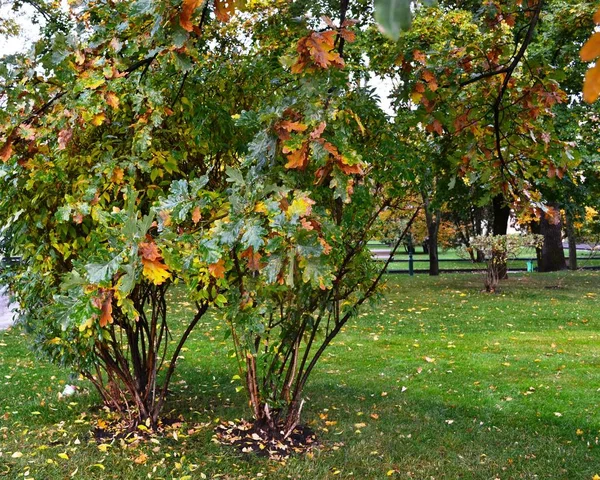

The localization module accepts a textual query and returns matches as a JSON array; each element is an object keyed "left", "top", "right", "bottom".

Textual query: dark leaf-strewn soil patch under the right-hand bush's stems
[{"left": 214, "top": 420, "right": 319, "bottom": 460}]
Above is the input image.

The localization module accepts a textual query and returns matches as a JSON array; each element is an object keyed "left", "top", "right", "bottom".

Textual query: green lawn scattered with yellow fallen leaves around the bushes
[{"left": 0, "top": 272, "right": 600, "bottom": 480}]
